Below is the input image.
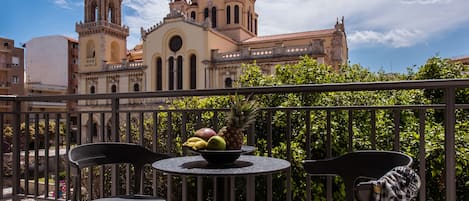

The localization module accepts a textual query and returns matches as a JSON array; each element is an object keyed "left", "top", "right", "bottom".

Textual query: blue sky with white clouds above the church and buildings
[{"left": 0, "top": 0, "right": 469, "bottom": 73}]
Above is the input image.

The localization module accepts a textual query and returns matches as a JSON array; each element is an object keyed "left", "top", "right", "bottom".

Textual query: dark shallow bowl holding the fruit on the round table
[{"left": 187, "top": 145, "right": 256, "bottom": 164}]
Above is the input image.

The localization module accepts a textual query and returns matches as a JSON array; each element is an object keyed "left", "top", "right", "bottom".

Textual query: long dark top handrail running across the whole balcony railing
[{"left": 0, "top": 79, "right": 469, "bottom": 102}]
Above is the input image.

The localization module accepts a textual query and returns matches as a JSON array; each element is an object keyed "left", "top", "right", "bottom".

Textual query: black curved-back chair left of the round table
[{"left": 68, "top": 142, "right": 169, "bottom": 201}]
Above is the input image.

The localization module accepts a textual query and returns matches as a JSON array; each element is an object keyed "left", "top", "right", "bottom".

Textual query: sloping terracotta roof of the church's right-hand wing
[{"left": 243, "top": 29, "right": 336, "bottom": 43}]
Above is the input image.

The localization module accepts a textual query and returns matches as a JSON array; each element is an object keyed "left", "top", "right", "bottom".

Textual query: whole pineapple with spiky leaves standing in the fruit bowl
[{"left": 218, "top": 95, "right": 259, "bottom": 150}]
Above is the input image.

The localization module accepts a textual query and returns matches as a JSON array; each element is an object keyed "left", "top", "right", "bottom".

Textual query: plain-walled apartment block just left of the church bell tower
[{"left": 25, "top": 35, "right": 78, "bottom": 115}]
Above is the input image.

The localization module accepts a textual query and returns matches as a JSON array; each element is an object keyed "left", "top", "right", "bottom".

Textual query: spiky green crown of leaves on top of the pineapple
[{"left": 227, "top": 95, "right": 259, "bottom": 130}]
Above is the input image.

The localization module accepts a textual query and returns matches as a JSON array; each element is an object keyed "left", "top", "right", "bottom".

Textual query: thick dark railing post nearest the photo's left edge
[{"left": 12, "top": 100, "right": 21, "bottom": 201}]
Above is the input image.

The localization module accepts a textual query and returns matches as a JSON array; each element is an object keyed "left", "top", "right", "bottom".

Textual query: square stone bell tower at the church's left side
[{"left": 76, "top": 0, "right": 129, "bottom": 73}]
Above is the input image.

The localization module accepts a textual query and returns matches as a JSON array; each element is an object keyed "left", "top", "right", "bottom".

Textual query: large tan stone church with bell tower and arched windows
[{"left": 76, "top": 0, "right": 348, "bottom": 139}]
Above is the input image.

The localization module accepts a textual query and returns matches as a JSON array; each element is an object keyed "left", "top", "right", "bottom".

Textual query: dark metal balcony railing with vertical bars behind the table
[{"left": 0, "top": 79, "right": 469, "bottom": 201}]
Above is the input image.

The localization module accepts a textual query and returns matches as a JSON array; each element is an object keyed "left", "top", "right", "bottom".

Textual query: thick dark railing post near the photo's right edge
[{"left": 445, "top": 87, "right": 456, "bottom": 201}]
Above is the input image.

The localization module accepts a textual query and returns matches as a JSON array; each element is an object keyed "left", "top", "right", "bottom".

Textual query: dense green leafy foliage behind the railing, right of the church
[{"left": 167, "top": 57, "right": 469, "bottom": 200}]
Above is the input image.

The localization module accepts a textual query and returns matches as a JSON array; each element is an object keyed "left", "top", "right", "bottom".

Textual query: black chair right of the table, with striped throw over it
[{"left": 303, "top": 150, "right": 412, "bottom": 201}]
